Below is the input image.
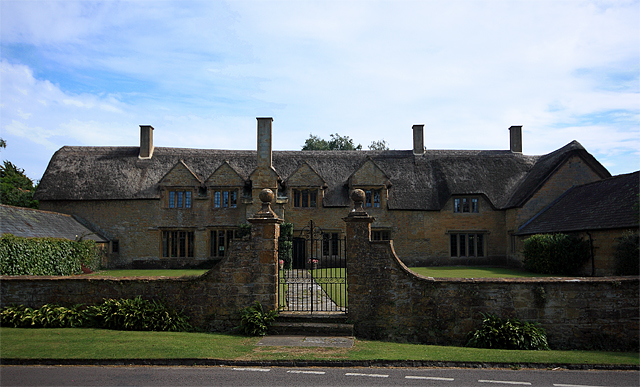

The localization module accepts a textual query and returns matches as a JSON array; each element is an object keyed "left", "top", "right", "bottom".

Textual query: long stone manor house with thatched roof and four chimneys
[{"left": 36, "top": 118, "right": 611, "bottom": 268}]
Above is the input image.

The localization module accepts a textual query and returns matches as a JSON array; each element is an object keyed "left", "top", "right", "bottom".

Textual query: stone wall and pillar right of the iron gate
[{"left": 346, "top": 212, "right": 640, "bottom": 350}]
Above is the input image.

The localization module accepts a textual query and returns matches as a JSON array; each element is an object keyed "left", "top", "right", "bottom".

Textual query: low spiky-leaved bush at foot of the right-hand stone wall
[{"left": 467, "top": 314, "right": 549, "bottom": 350}]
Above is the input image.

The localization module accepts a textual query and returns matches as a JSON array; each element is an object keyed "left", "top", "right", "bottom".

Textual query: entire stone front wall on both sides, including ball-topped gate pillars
[{"left": 0, "top": 193, "right": 640, "bottom": 350}]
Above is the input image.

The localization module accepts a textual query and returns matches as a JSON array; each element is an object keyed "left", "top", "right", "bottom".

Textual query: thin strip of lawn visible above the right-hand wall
[{"left": 409, "top": 266, "right": 558, "bottom": 278}]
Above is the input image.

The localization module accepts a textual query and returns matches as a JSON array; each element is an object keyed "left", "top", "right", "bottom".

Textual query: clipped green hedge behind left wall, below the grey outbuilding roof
[{"left": 0, "top": 234, "right": 102, "bottom": 275}]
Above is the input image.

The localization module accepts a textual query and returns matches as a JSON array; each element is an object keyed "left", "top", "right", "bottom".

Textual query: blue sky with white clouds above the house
[{"left": 0, "top": 0, "right": 640, "bottom": 179}]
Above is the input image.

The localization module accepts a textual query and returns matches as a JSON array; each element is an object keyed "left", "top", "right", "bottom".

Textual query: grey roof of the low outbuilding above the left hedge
[{"left": 0, "top": 204, "right": 108, "bottom": 243}]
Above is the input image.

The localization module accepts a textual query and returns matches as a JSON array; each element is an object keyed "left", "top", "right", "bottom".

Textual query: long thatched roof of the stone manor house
[{"left": 35, "top": 141, "right": 610, "bottom": 211}]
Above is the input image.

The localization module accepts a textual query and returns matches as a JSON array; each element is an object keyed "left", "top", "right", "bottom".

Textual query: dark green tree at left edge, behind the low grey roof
[{"left": 0, "top": 160, "right": 38, "bottom": 208}]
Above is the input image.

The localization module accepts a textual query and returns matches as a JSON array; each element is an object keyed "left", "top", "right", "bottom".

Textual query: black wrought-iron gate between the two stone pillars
[{"left": 278, "top": 220, "right": 347, "bottom": 313}]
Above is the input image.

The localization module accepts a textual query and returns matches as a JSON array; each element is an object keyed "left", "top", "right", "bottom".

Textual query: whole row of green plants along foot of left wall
[{"left": 0, "top": 296, "right": 192, "bottom": 331}]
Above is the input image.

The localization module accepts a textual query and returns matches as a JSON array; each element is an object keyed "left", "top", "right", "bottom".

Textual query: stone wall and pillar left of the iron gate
[{"left": 0, "top": 208, "right": 280, "bottom": 331}]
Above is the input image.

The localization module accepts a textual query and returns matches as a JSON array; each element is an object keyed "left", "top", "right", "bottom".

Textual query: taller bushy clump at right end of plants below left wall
[{"left": 85, "top": 296, "right": 191, "bottom": 332}]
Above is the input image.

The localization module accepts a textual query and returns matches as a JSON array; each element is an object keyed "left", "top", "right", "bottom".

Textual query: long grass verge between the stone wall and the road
[{"left": 0, "top": 328, "right": 640, "bottom": 365}]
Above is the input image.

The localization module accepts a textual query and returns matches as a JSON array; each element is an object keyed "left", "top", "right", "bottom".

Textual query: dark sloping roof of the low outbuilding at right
[{"left": 518, "top": 172, "right": 640, "bottom": 235}]
